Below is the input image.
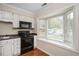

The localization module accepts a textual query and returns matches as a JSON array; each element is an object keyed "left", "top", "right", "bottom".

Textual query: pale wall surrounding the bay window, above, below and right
[{"left": 37, "top": 4, "right": 79, "bottom": 56}]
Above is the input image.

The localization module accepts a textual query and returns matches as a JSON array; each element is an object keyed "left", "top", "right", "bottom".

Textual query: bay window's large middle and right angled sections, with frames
[{"left": 47, "top": 10, "right": 74, "bottom": 46}]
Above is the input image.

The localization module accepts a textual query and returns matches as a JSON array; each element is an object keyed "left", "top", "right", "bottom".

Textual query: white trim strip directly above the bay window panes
[{"left": 38, "top": 4, "right": 75, "bottom": 19}]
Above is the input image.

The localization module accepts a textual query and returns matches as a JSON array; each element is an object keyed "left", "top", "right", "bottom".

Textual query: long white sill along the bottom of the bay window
[{"left": 38, "top": 38, "right": 79, "bottom": 53}]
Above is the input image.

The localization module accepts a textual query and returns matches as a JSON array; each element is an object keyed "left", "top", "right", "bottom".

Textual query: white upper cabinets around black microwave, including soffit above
[{"left": 0, "top": 4, "right": 34, "bottom": 28}]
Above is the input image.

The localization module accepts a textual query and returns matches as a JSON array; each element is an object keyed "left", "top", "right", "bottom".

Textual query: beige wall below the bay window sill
[{"left": 37, "top": 40, "right": 79, "bottom": 56}]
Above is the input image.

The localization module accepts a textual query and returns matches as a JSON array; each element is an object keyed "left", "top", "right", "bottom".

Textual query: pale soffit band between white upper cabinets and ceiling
[{"left": 0, "top": 3, "right": 35, "bottom": 17}]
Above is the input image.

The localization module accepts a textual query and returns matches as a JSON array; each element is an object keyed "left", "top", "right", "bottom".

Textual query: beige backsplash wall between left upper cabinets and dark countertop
[{"left": 0, "top": 22, "right": 18, "bottom": 35}]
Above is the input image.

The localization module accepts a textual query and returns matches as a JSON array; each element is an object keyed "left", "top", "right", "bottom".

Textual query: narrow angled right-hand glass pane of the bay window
[{"left": 66, "top": 12, "right": 73, "bottom": 45}]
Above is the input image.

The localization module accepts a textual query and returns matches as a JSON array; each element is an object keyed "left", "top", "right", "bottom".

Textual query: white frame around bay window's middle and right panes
[{"left": 46, "top": 7, "right": 75, "bottom": 47}]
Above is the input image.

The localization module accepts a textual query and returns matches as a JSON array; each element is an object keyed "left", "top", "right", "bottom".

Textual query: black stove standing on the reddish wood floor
[{"left": 18, "top": 31, "right": 34, "bottom": 54}]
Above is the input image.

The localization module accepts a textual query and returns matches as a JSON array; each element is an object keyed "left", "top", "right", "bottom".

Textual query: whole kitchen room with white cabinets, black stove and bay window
[{"left": 0, "top": 3, "right": 79, "bottom": 56}]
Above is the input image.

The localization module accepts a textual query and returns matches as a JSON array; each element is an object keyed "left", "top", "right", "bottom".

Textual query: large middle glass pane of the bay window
[{"left": 47, "top": 16, "right": 64, "bottom": 41}]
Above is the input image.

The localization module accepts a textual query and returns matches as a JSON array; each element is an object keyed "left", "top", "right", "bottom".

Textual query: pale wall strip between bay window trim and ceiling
[{"left": 36, "top": 3, "right": 74, "bottom": 18}]
